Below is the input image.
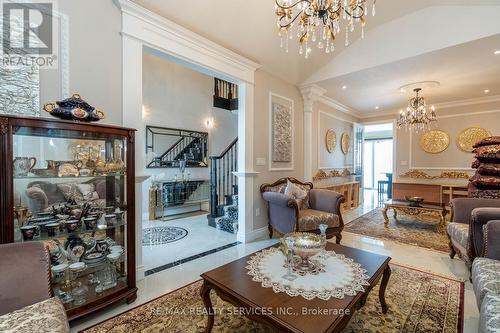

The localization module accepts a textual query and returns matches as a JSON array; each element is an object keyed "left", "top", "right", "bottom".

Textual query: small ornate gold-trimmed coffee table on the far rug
[{"left": 382, "top": 200, "right": 448, "bottom": 233}]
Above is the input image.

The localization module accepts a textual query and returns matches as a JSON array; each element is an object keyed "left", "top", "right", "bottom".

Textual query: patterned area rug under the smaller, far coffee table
[{"left": 344, "top": 209, "right": 448, "bottom": 252}]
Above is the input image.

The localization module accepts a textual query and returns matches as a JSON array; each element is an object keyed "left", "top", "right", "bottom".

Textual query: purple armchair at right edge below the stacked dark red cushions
[{"left": 447, "top": 198, "right": 500, "bottom": 269}]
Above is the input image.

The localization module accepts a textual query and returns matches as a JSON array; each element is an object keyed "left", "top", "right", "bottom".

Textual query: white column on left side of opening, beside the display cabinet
[{"left": 122, "top": 35, "right": 148, "bottom": 281}]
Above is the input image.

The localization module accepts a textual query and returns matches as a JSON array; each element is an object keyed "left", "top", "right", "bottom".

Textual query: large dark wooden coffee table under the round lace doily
[{"left": 200, "top": 243, "right": 391, "bottom": 333}]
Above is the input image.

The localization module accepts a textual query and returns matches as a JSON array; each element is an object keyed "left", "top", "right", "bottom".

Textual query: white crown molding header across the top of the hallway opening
[{"left": 113, "top": 0, "right": 261, "bottom": 80}]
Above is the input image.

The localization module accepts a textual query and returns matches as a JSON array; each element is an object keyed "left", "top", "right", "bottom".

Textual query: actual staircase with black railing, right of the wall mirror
[{"left": 208, "top": 138, "right": 238, "bottom": 234}]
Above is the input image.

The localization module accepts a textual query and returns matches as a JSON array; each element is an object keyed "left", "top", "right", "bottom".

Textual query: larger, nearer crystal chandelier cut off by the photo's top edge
[{"left": 275, "top": 0, "right": 376, "bottom": 58}]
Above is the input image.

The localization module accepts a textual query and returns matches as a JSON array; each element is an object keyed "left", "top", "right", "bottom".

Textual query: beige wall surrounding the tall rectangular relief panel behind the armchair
[{"left": 253, "top": 70, "right": 304, "bottom": 229}]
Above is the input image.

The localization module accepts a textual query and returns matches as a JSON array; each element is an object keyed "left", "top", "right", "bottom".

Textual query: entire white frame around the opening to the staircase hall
[{"left": 114, "top": 0, "right": 260, "bottom": 279}]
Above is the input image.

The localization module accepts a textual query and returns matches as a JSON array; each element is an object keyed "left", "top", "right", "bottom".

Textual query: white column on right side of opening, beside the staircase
[{"left": 235, "top": 83, "right": 258, "bottom": 243}]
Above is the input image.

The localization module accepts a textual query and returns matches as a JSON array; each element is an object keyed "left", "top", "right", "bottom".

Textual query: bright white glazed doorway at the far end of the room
[{"left": 363, "top": 123, "right": 394, "bottom": 203}]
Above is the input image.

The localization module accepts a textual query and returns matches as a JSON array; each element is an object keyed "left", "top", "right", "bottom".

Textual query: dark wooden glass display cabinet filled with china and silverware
[{"left": 0, "top": 115, "right": 137, "bottom": 320}]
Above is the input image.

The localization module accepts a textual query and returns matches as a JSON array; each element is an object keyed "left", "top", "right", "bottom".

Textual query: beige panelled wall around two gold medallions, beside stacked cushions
[{"left": 363, "top": 103, "right": 500, "bottom": 184}]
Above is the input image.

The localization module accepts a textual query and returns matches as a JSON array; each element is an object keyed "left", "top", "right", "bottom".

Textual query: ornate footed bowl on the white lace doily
[{"left": 281, "top": 232, "right": 326, "bottom": 271}]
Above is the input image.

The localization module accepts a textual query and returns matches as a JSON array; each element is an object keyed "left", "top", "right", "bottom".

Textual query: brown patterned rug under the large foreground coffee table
[{"left": 82, "top": 263, "right": 464, "bottom": 333}]
